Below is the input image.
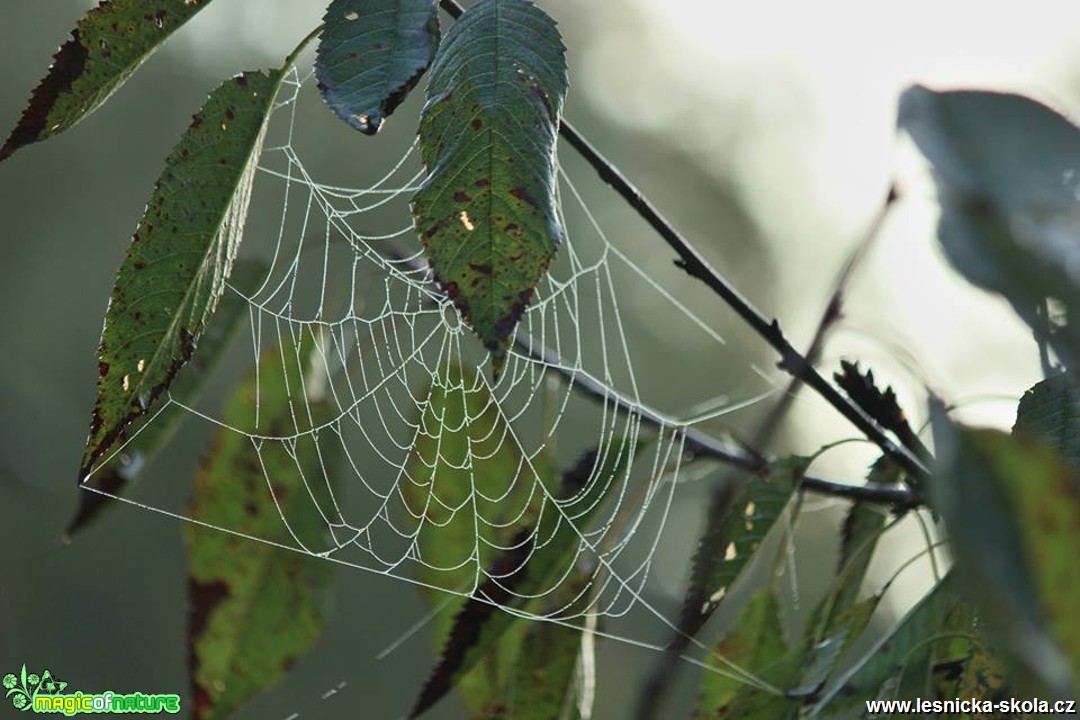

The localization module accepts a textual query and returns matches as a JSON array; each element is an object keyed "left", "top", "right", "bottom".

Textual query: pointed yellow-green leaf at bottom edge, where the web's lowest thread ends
[{"left": 692, "top": 587, "right": 799, "bottom": 720}]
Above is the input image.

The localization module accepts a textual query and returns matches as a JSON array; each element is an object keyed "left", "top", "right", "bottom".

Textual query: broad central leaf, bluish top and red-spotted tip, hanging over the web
[{"left": 413, "top": 0, "right": 567, "bottom": 376}]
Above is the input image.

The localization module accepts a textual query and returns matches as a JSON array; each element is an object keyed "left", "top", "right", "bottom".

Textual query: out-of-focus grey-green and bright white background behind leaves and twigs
[{"left": 0, "top": 0, "right": 1080, "bottom": 718}]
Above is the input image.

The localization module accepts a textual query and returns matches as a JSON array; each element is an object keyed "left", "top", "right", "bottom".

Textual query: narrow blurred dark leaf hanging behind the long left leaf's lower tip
[{"left": 65, "top": 260, "right": 267, "bottom": 539}]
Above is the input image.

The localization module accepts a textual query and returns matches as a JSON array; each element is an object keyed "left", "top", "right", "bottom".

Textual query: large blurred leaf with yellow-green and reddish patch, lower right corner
[{"left": 931, "top": 400, "right": 1080, "bottom": 697}]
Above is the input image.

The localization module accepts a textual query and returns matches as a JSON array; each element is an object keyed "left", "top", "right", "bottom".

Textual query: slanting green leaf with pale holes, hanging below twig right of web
[{"left": 678, "top": 457, "right": 810, "bottom": 636}]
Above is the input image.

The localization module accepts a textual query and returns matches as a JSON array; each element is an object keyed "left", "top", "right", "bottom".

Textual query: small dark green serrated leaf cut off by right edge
[{"left": 1013, "top": 372, "right": 1080, "bottom": 479}]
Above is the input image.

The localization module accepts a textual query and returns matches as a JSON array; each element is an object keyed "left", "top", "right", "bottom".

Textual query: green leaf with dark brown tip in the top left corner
[{"left": 0, "top": 0, "right": 210, "bottom": 161}]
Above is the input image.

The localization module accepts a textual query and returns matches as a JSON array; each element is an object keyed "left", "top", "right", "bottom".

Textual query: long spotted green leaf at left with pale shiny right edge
[{"left": 79, "top": 70, "right": 283, "bottom": 480}]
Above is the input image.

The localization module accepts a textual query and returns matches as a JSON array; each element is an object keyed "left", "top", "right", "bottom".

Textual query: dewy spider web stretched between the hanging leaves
[{"left": 78, "top": 71, "right": 779, "bottom": 708}]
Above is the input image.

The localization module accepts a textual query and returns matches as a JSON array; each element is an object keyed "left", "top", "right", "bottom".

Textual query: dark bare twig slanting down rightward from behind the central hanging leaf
[{"left": 440, "top": 0, "right": 929, "bottom": 487}]
